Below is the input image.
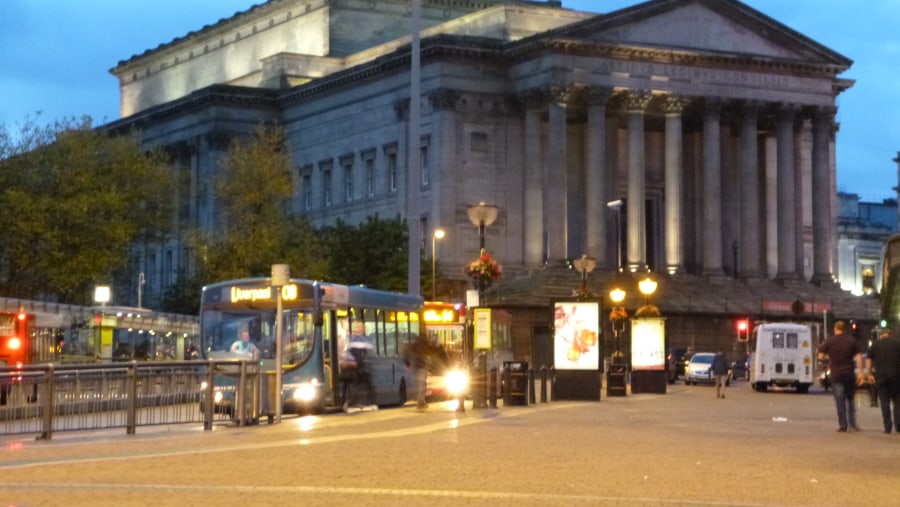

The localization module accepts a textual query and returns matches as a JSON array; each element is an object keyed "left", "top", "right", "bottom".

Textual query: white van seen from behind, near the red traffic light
[{"left": 749, "top": 322, "right": 815, "bottom": 393}]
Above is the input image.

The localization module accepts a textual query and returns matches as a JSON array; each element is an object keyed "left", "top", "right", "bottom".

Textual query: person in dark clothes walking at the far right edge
[{"left": 866, "top": 328, "right": 900, "bottom": 433}]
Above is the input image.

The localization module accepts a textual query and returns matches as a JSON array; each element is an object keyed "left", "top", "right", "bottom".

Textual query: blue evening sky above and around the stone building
[{"left": 0, "top": 0, "right": 900, "bottom": 202}]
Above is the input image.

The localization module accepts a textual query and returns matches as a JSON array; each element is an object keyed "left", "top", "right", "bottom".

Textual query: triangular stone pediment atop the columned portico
[{"left": 557, "top": 0, "right": 851, "bottom": 66}]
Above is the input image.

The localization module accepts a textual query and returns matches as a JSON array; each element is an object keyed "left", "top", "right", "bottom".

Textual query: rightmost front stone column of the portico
[{"left": 812, "top": 106, "right": 835, "bottom": 283}]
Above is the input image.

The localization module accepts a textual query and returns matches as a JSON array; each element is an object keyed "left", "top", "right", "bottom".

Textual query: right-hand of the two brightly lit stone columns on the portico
[{"left": 662, "top": 95, "right": 688, "bottom": 274}]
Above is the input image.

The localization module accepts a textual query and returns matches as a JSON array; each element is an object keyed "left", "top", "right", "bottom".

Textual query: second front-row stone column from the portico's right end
[{"left": 775, "top": 104, "right": 797, "bottom": 279}]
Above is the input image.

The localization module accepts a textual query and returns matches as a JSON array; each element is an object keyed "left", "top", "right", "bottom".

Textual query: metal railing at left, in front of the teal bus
[{"left": 0, "top": 361, "right": 261, "bottom": 439}]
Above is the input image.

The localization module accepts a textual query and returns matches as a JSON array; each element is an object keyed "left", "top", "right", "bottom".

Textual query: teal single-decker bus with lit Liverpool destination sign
[{"left": 200, "top": 278, "right": 424, "bottom": 417}]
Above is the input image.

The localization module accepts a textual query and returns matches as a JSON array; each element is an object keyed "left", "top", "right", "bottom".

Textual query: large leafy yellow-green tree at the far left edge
[{"left": 0, "top": 117, "right": 172, "bottom": 304}]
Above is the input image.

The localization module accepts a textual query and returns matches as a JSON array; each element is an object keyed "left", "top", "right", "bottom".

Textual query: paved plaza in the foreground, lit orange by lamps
[{"left": 0, "top": 382, "right": 900, "bottom": 507}]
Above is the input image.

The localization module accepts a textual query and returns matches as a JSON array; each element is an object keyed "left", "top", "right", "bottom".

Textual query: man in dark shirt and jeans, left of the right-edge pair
[{"left": 818, "top": 320, "right": 865, "bottom": 432}]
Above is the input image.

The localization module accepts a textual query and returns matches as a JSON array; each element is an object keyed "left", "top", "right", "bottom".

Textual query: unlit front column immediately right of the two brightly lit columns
[{"left": 702, "top": 99, "right": 725, "bottom": 276}]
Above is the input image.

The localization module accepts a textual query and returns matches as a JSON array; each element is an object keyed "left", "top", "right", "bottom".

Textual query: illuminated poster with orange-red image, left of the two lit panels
[{"left": 553, "top": 302, "right": 600, "bottom": 370}]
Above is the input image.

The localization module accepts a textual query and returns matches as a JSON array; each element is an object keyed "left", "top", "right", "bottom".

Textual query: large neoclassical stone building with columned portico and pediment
[{"left": 109, "top": 0, "right": 877, "bottom": 356}]
